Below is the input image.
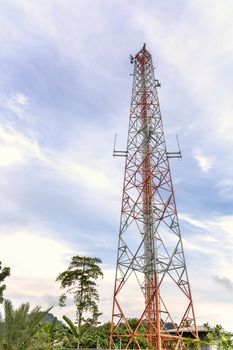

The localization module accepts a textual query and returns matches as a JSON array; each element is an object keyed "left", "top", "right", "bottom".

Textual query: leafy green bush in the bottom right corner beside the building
[{"left": 204, "top": 323, "right": 233, "bottom": 350}]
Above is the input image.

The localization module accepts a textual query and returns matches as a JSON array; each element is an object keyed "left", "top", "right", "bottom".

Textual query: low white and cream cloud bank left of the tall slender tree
[{"left": 0, "top": 224, "right": 81, "bottom": 317}]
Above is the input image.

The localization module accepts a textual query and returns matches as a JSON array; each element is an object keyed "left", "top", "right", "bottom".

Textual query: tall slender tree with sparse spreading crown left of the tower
[{"left": 56, "top": 255, "right": 103, "bottom": 330}]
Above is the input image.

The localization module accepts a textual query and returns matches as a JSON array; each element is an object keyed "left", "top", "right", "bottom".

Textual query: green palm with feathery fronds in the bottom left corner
[{"left": 0, "top": 300, "right": 49, "bottom": 350}]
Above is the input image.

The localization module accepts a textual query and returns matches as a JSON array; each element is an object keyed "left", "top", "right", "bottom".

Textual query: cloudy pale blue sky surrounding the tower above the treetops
[{"left": 0, "top": 0, "right": 233, "bottom": 331}]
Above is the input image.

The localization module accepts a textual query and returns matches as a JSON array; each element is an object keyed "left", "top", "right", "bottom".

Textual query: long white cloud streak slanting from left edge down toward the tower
[{"left": 0, "top": 125, "right": 119, "bottom": 201}]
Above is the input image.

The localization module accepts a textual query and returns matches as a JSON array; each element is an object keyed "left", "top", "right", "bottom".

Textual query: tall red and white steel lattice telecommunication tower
[{"left": 110, "top": 45, "right": 198, "bottom": 350}]
